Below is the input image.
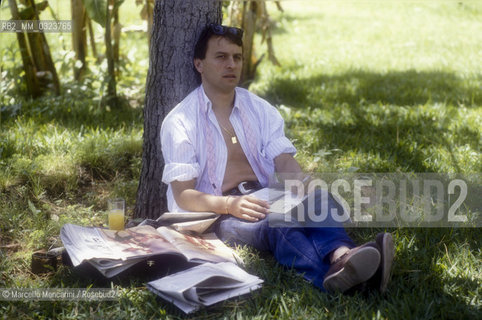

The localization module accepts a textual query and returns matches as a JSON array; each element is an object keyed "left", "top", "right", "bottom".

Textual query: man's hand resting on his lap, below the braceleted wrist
[{"left": 226, "top": 196, "right": 269, "bottom": 221}]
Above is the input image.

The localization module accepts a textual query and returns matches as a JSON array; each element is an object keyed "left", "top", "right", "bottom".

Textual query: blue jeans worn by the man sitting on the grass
[{"left": 215, "top": 192, "right": 355, "bottom": 290}]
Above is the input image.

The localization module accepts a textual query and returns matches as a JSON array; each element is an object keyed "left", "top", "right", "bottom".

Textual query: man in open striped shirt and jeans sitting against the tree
[{"left": 161, "top": 24, "right": 393, "bottom": 292}]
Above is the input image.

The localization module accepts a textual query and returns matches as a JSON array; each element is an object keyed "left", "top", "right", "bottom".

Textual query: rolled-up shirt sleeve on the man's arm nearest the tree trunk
[{"left": 161, "top": 117, "right": 200, "bottom": 184}]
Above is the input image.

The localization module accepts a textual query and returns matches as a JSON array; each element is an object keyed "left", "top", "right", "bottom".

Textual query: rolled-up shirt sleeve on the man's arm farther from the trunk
[{"left": 264, "top": 105, "right": 296, "bottom": 159}]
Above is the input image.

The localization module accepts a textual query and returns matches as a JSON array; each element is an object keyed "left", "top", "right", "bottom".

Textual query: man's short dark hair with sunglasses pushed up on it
[{"left": 194, "top": 23, "right": 243, "bottom": 59}]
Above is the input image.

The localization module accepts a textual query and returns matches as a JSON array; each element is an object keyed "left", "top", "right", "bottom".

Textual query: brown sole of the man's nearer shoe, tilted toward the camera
[{"left": 323, "top": 247, "right": 380, "bottom": 293}]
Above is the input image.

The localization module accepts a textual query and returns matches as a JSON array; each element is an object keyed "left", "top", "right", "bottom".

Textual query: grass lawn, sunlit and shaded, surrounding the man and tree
[{"left": 0, "top": 0, "right": 482, "bottom": 319}]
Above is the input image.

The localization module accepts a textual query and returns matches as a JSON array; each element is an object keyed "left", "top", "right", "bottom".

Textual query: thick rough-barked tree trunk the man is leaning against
[{"left": 135, "top": 0, "right": 222, "bottom": 218}]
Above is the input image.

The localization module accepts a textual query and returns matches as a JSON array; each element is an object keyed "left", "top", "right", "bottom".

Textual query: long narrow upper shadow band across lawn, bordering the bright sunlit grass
[{"left": 266, "top": 70, "right": 482, "bottom": 108}]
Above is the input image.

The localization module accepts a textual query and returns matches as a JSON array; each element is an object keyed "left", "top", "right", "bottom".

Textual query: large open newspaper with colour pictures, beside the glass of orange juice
[{"left": 60, "top": 224, "right": 242, "bottom": 278}]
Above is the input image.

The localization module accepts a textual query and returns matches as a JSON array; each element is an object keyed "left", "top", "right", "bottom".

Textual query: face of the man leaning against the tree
[{"left": 194, "top": 37, "right": 243, "bottom": 93}]
